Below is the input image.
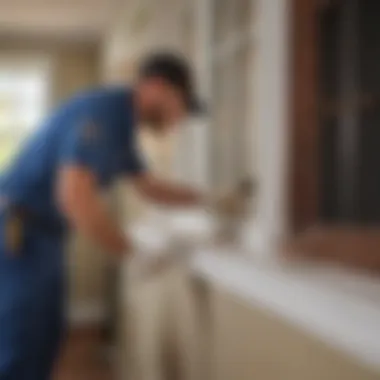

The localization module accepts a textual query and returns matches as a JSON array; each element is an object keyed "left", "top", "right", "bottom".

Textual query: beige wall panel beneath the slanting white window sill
[{"left": 211, "top": 289, "right": 380, "bottom": 380}]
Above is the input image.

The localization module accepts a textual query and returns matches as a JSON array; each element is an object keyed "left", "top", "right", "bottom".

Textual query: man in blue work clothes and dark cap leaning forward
[{"left": 0, "top": 53, "right": 206, "bottom": 380}]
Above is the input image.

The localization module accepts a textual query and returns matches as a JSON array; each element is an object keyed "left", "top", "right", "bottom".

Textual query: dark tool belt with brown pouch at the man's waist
[{"left": 0, "top": 197, "right": 66, "bottom": 256}]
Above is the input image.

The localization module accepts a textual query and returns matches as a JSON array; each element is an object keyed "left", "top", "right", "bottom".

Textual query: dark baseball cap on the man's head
[{"left": 139, "top": 52, "right": 206, "bottom": 114}]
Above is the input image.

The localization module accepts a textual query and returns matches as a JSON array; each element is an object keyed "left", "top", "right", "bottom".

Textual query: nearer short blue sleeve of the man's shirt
[{"left": 59, "top": 113, "right": 108, "bottom": 176}]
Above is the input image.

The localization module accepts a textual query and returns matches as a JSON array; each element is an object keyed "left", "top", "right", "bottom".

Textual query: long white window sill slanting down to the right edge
[{"left": 192, "top": 249, "right": 380, "bottom": 370}]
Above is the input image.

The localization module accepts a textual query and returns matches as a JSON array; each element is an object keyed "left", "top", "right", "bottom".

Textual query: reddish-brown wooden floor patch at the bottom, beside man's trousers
[{"left": 54, "top": 328, "right": 114, "bottom": 380}]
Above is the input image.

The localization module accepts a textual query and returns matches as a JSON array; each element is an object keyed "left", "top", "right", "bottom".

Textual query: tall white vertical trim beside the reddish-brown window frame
[{"left": 252, "top": 0, "right": 289, "bottom": 255}]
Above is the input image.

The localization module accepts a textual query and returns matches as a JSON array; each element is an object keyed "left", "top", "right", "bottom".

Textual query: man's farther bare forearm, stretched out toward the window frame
[{"left": 133, "top": 174, "right": 204, "bottom": 206}]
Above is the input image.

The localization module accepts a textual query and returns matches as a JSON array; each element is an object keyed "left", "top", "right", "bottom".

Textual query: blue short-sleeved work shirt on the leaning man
[{"left": 0, "top": 88, "right": 144, "bottom": 229}]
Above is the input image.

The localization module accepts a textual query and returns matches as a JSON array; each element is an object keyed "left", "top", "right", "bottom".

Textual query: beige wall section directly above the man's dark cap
[{"left": 103, "top": 0, "right": 190, "bottom": 80}]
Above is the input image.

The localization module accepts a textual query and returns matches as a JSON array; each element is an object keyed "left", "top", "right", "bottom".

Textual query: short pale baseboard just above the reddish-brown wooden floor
[{"left": 68, "top": 302, "right": 107, "bottom": 326}]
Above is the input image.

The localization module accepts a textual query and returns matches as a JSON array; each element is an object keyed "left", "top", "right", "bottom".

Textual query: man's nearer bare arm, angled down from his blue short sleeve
[{"left": 56, "top": 166, "right": 131, "bottom": 254}]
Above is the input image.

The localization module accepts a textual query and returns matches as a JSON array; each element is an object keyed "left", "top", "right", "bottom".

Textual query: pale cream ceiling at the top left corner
[{"left": 0, "top": 0, "right": 121, "bottom": 39}]
